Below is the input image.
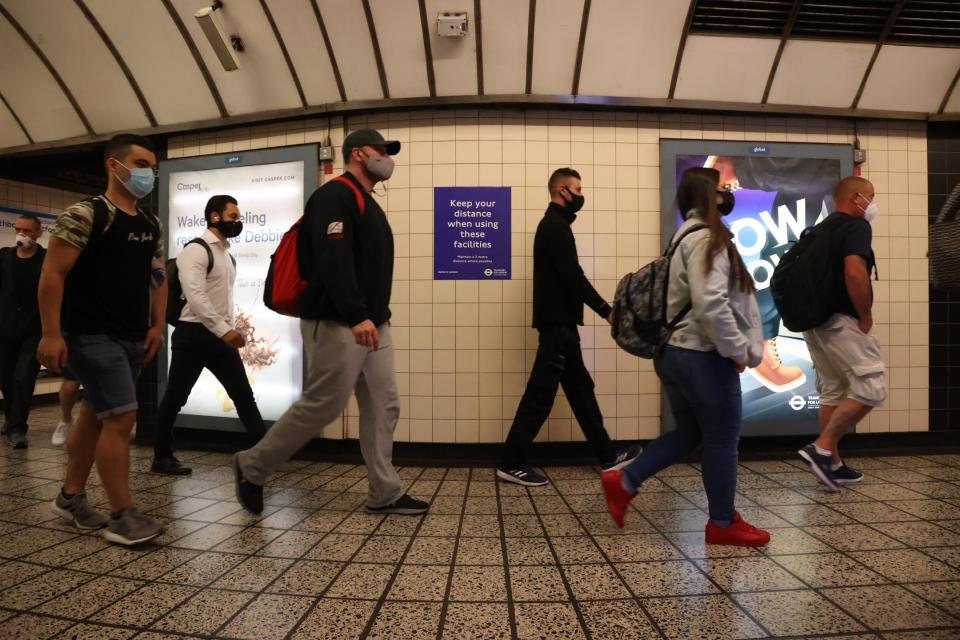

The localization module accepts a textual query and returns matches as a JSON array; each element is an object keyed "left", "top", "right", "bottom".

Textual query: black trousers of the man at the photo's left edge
[{"left": 0, "top": 335, "right": 40, "bottom": 433}]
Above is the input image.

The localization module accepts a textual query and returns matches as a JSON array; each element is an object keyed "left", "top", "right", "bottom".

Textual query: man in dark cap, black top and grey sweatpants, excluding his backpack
[{"left": 234, "top": 129, "right": 430, "bottom": 515}]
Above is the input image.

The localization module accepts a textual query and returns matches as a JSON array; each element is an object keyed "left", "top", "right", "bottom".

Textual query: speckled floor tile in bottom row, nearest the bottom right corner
[{"left": 822, "top": 585, "right": 960, "bottom": 630}]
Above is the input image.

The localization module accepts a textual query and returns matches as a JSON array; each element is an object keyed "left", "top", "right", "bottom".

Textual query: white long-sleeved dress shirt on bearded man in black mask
[{"left": 177, "top": 229, "right": 237, "bottom": 338}]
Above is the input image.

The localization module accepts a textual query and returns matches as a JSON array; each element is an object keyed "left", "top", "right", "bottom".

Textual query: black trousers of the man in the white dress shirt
[{"left": 153, "top": 322, "right": 266, "bottom": 459}]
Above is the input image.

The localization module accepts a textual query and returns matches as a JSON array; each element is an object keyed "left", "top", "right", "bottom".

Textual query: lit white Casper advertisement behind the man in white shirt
[{"left": 161, "top": 150, "right": 317, "bottom": 428}]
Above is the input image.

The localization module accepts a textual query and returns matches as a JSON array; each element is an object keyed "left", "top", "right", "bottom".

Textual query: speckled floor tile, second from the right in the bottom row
[{"left": 733, "top": 590, "right": 865, "bottom": 636}]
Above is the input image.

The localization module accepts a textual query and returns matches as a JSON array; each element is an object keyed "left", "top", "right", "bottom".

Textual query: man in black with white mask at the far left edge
[{"left": 0, "top": 215, "right": 46, "bottom": 449}]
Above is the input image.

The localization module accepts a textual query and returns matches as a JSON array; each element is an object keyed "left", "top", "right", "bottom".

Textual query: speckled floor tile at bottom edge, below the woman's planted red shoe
[{"left": 643, "top": 595, "right": 767, "bottom": 640}]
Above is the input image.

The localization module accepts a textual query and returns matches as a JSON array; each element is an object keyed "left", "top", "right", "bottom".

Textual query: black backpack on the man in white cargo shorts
[{"left": 770, "top": 216, "right": 845, "bottom": 331}]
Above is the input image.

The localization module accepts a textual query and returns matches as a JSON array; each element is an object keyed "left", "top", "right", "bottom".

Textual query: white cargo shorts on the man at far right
[{"left": 803, "top": 313, "right": 887, "bottom": 407}]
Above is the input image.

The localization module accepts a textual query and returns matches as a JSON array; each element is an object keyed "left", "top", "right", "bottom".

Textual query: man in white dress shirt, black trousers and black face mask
[{"left": 150, "top": 195, "right": 264, "bottom": 476}]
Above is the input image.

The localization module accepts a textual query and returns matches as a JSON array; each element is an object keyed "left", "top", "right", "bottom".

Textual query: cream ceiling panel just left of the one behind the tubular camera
[{"left": 86, "top": 0, "right": 220, "bottom": 124}]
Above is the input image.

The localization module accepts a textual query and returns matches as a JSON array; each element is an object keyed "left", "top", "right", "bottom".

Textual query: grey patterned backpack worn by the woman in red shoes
[{"left": 611, "top": 224, "right": 707, "bottom": 358}]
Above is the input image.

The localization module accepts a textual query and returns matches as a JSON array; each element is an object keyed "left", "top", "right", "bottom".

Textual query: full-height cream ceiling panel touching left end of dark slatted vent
[{"left": 567, "top": 0, "right": 689, "bottom": 98}]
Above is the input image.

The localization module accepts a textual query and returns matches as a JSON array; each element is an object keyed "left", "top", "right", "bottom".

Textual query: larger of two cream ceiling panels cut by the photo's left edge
[{"left": 0, "top": 18, "right": 87, "bottom": 142}]
